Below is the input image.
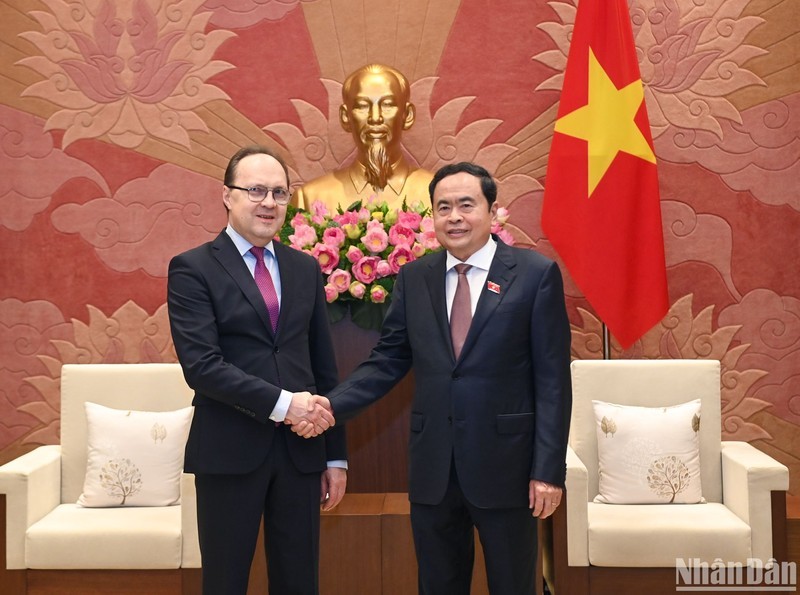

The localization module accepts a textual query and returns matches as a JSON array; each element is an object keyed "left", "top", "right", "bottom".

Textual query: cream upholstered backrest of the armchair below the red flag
[{"left": 569, "top": 360, "right": 722, "bottom": 502}]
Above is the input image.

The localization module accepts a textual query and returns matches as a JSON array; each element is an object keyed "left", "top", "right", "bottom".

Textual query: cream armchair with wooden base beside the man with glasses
[{"left": 0, "top": 364, "right": 200, "bottom": 595}]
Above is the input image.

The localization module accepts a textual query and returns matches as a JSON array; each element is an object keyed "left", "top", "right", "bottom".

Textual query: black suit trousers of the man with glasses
[{"left": 195, "top": 426, "right": 320, "bottom": 595}]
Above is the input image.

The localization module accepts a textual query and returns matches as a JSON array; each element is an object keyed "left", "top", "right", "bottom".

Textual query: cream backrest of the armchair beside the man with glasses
[{"left": 61, "top": 364, "right": 194, "bottom": 502}]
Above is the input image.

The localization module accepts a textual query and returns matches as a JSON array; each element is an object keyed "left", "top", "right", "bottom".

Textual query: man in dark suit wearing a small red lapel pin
[{"left": 297, "top": 163, "right": 572, "bottom": 595}]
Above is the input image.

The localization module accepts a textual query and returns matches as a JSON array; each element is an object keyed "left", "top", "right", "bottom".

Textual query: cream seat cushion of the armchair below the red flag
[{"left": 588, "top": 502, "right": 751, "bottom": 567}]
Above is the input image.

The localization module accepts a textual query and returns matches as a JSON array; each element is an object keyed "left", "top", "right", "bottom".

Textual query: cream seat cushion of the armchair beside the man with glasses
[{"left": 25, "top": 504, "right": 182, "bottom": 569}]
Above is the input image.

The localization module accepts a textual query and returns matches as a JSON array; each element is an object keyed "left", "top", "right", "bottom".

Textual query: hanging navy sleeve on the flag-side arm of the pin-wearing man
[{"left": 530, "top": 262, "right": 572, "bottom": 487}]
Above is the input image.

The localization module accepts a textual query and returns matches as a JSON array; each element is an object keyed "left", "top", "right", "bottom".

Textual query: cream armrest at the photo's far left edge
[{"left": 0, "top": 445, "right": 61, "bottom": 569}]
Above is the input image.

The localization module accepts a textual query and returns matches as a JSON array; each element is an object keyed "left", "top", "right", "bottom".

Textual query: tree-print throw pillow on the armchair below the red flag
[{"left": 592, "top": 399, "right": 702, "bottom": 504}]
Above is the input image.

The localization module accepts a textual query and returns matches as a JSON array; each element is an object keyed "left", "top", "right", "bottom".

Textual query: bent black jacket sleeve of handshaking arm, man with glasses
[{"left": 167, "top": 255, "right": 281, "bottom": 423}]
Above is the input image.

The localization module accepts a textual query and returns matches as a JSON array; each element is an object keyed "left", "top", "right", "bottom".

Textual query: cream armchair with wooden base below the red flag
[{"left": 544, "top": 360, "right": 789, "bottom": 595}]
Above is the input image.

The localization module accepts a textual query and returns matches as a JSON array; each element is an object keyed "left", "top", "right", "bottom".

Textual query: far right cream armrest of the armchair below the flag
[{"left": 722, "top": 442, "right": 789, "bottom": 562}]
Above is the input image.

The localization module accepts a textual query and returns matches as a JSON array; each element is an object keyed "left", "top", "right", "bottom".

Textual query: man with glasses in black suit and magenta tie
[{"left": 168, "top": 147, "right": 346, "bottom": 595}]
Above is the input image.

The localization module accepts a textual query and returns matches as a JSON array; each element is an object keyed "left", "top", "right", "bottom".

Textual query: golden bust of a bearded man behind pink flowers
[{"left": 294, "top": 64, "right": 433, "bottom": 212}]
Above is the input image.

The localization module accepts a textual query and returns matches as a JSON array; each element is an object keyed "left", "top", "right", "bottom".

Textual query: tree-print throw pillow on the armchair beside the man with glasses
[{"left": 78, "top": 402, "right": 193, "bottom": 507}]
